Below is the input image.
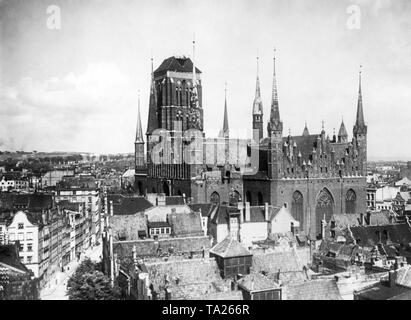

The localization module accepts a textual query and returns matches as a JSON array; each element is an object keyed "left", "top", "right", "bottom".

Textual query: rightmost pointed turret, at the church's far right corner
[{"left": 353, "top": 66, "right": 367, "bottom": 176}]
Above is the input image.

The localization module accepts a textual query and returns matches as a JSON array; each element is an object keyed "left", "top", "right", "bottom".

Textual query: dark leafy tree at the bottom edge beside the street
[{"left": 67, "top": 259, "right": 120, "bottom": 300}]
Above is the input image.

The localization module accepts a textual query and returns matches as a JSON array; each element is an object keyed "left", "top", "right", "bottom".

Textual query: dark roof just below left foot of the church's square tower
[{"left": 107, "top": 194, "right": 153, "bottom": 215}]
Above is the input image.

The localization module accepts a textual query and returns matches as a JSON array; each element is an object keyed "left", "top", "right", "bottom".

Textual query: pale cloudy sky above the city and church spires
[{"left": 0, "top": 0, "right": 411, "bottom": 160}]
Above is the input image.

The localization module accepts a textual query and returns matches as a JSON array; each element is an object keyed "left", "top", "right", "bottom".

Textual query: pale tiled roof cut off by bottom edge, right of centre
[{"left": 286, "top": 279, "right": 342, "bottom": 300}]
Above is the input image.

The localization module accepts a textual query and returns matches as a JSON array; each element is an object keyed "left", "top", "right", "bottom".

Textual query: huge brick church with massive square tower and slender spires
[{"left": 135, "top": 46, "right": 367, "bottom": 236}]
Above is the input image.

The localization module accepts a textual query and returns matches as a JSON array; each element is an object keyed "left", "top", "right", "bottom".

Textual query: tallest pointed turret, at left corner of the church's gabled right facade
[{"left": 267, "top": 49, "right": 283, "bottom": 179}]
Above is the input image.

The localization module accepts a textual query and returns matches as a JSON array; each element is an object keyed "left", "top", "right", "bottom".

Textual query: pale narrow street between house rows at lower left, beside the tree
[{"left": 40, "top": 243, "right": 102, "bottom": 300}]
